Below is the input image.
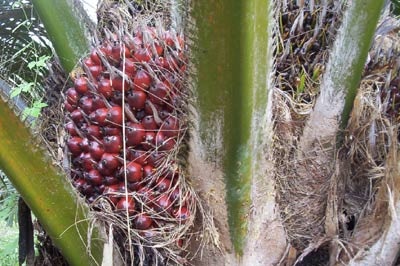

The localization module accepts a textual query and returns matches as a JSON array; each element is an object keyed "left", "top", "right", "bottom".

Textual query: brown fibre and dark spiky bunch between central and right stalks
[{"left": 274, "top": 1, "right": 343, "bottom": 251}]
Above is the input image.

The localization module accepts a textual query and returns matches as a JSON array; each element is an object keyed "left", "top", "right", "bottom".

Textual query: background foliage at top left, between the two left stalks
[{"left": 0, "top": 0, "right": 52, "bottom": 119}]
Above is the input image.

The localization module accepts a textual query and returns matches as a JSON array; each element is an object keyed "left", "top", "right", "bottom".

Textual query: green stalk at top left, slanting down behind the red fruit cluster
[{"left": 32, "top": 0, "right": 89, "bottom": 72}]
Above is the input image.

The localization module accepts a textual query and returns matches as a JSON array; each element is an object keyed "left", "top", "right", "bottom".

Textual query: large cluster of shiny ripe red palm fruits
[{"left": 65, "top": 27, "right": 189, "bottom": 230}]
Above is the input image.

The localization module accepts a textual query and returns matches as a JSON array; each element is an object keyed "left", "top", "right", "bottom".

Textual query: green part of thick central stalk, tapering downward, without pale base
[{"left": 193, "top": 0, "right": 271, "bottom": 255}]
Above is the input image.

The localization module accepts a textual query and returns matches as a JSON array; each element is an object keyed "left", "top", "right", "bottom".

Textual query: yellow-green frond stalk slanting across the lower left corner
[{"left": 0, "top": 93, "right": 103, "bottom": 265}]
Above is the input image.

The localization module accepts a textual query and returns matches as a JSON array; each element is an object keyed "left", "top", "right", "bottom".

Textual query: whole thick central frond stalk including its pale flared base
[{"left": 189, "top": 0, "right": 286, "bottom": 265}]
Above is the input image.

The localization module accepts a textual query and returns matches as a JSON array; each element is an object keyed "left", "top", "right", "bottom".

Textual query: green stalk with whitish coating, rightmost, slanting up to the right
[{"left": 304, "top": 0, "right": 385, "bottom": 143}]
